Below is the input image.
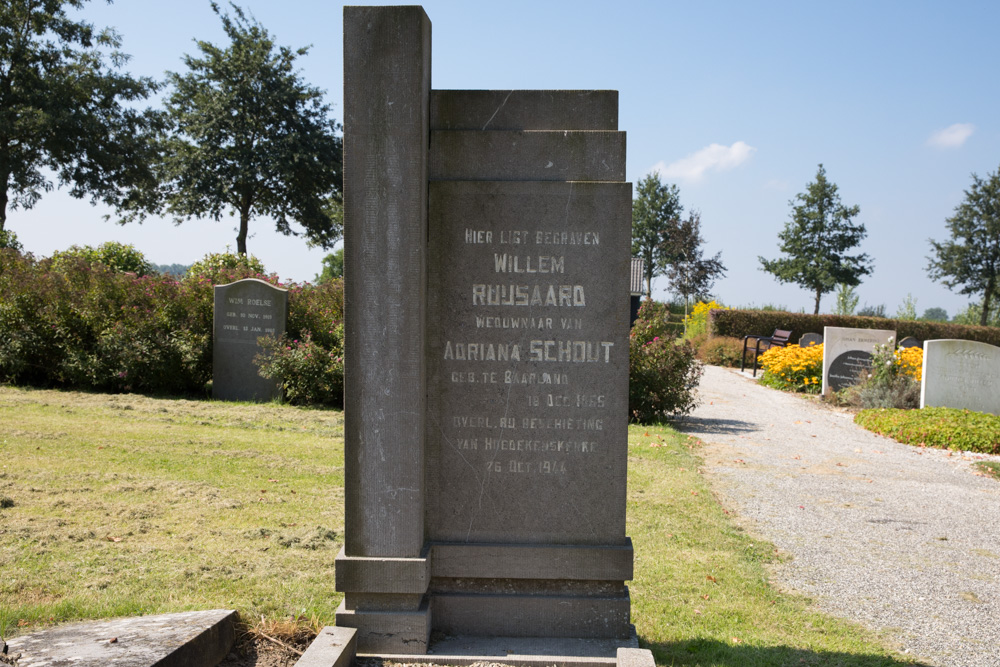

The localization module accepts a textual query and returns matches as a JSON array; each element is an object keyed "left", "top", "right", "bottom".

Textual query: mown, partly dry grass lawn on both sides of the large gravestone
[{"left": 0, "top": 387, "right": 911, "bottom": 667}]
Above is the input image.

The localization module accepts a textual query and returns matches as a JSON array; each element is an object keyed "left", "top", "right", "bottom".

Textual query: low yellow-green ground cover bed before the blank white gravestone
[{"left": 854, "top": 408, "right": 1000, "bottom": 454}]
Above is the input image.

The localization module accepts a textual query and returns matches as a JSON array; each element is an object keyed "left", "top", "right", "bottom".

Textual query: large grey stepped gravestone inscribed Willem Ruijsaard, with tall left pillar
[{"left": 336, "top": 7, "right": 651, "bottom": 664}]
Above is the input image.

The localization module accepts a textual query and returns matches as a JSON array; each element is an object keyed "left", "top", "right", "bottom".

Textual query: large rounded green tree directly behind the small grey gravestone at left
[{"left": 139, "top": 2, "right": 343, "bottom": 255}]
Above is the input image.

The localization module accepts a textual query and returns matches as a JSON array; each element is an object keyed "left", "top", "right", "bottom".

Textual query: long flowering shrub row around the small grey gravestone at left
[{"left": 0, "top": 244, "right": 344, "bottom": 404}]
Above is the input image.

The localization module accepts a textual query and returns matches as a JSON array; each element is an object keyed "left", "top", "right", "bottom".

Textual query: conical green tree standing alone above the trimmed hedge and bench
[{"left": 758, "top": 164, "right": 872, "bottom": 315}]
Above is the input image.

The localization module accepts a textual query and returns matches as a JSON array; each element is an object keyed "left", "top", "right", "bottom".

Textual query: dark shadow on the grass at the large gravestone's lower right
[{"left": 640, "top": 639, "right": 930, "bottom": 667}]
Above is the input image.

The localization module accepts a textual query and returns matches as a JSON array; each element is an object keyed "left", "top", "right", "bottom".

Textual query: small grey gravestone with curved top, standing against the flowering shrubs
[{"left": 212, "top": 278, "right": 288, "bottom": 401}]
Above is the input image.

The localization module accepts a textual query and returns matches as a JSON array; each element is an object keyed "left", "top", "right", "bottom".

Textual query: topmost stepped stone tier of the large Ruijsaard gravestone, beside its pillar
[{"left": 431, "top": 90, "right": 618, "bottom": 130}]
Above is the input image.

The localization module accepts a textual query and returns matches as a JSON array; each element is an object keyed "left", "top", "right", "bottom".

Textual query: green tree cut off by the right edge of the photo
[{"left": 927, "top": 164, "right": 1000, "bottom": 326}]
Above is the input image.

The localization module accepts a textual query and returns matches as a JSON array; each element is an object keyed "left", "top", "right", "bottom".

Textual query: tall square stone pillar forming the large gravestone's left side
[{"left": 336, "top": 7, "right": 431, "bottom": 653}]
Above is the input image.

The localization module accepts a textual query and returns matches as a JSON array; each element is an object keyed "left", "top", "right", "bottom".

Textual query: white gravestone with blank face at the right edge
[{"left": 920, "top": 340, "right": 1000, "bottom": 415}]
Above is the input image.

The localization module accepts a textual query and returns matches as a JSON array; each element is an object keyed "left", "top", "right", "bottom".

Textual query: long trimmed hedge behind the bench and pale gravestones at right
[{"left": 708, "top": 310, "right": 1000, "bottom": 347}]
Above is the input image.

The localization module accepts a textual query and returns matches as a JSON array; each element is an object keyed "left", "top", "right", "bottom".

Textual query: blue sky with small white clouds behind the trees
[{"left": 8, "top": 0, "right": 1000, "bottom": 315}]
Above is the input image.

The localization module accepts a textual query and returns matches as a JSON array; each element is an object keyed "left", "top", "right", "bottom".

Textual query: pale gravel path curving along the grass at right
[{"left": 679, "top": 367, "right": 1000, "bottom": 667}]
